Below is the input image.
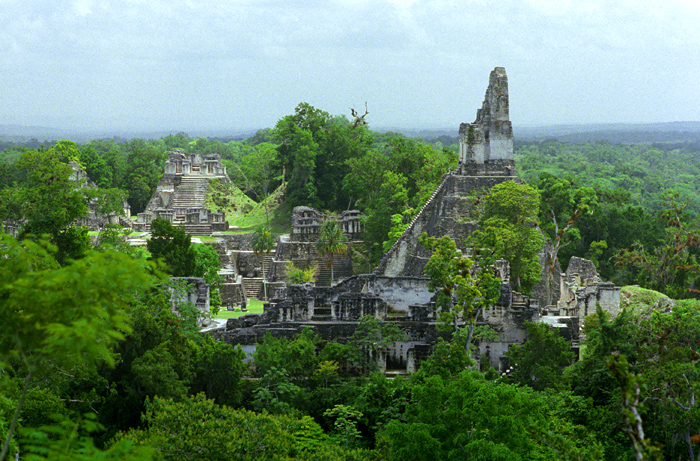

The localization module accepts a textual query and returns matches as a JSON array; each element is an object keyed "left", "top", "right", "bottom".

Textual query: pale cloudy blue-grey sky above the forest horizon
[{"left": 0, "top": 0, "right": 700, "bottom": 132}]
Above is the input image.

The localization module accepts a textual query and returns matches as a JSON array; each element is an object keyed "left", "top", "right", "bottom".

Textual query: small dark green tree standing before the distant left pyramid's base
[{"left": 146, "top": 217, "right": 195, "bottom": 277}]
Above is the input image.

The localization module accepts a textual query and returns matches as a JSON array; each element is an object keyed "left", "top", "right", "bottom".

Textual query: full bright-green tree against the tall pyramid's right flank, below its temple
[{"left": 467, "top": 181, "right": 543, "bottom": 291}]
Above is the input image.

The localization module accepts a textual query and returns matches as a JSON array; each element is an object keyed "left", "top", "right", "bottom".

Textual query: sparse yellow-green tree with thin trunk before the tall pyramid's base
[{"left": 420, "top": 232, "right": 501, "bottom": 353}]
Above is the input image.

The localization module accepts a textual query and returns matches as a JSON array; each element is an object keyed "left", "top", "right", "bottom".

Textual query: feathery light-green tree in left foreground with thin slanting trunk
[{"left": 0, "top": 234, "right": 158, "bottom": 459}]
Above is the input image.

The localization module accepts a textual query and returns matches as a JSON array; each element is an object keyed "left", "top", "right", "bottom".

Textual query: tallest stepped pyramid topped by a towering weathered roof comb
[{"left": 374, "top": 67, "right": 519, "bottom": 277}]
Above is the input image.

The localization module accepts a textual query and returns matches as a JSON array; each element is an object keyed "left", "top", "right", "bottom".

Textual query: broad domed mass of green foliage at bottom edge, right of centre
[{"left": 386, "top": 370, "right": 600, "bottom": 461}]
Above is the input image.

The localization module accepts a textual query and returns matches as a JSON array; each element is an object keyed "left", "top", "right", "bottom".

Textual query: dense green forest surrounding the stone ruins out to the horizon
[{"left": 0, "top": 109, "right": 700, "bottom": 460}]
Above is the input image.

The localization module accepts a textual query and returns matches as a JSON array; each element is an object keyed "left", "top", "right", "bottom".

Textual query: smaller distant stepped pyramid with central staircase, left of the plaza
[{"left": 133, "top": 149, "right": 230, "bottom": 235}]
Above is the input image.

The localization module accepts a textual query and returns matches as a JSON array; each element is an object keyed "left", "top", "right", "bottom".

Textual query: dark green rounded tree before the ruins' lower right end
[{"left": 505, "top": 322, "right": 574, "bottom": 391}]
